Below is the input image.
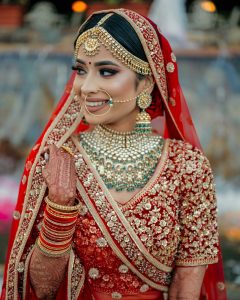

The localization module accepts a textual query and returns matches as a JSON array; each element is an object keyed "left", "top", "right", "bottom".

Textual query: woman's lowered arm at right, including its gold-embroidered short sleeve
[{"left": 170, "top": 147, "right": 218, "bottom": 300}]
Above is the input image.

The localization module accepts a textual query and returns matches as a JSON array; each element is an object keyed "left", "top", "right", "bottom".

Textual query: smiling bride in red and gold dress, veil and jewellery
[{"left": 1, "top": 9, "right": 226, "bottom": 300}]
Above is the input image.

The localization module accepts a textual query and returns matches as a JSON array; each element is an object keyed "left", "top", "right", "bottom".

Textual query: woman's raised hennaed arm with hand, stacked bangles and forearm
[{"left": 29, "top": 145, "right": 77, "bottom": 300}]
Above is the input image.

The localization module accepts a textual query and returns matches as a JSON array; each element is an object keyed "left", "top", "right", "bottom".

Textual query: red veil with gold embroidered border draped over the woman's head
[{"left": 1, "top": 9, "right": 226, "bottom": 300}]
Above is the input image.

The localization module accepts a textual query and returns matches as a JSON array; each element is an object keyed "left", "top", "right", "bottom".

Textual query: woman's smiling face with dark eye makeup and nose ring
[{"left": 73, "top": 46, "right": 149, "bottom": 131}]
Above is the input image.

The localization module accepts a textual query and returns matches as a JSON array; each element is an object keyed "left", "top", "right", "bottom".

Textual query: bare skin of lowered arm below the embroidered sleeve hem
[{"left": 169, "top": 266, "right": 206, "bottom": 300}]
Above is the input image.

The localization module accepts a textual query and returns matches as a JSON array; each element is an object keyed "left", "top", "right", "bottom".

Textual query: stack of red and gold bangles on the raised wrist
[{"left": 37, "top": 197, "right": 80, "bottom": 257}]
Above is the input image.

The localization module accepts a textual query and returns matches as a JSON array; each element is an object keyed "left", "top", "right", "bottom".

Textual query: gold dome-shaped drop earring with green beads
[{"left": 135, "top": 91, "right": 152, "bottom": 134}]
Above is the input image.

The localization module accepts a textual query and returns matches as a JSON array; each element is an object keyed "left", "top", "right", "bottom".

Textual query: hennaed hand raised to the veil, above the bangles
[{"left": 43, "top": 145, "right": 77, "bottom": 205}]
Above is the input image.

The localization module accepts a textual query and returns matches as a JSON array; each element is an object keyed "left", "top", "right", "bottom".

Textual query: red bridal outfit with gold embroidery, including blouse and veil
[{"left": 1, "top": 9, "right": 226, "bottom": 300}]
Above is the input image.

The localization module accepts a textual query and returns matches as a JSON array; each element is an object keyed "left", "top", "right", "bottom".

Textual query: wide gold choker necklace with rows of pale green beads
[{"left": 80, "top": 125, "right": 163, "bottom": 191}]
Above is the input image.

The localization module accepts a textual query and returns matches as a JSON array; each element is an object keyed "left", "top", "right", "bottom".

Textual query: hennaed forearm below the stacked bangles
[{"left": 30, "top": 247, "right": 69, "bottom": 300}]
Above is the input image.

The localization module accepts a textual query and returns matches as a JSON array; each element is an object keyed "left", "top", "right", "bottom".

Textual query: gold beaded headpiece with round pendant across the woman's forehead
[{"left": 75, "top": 13, "right": 151, "bottom": 75}]
